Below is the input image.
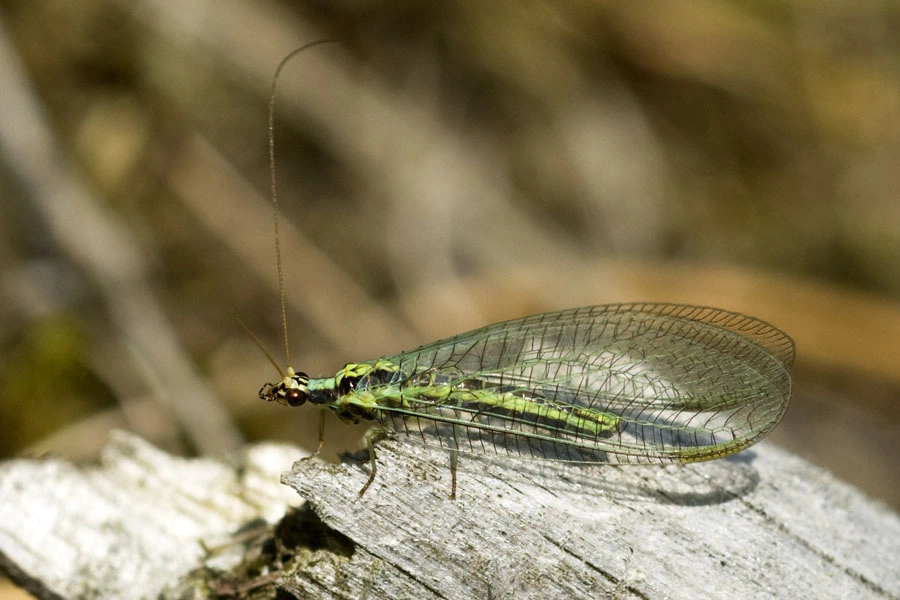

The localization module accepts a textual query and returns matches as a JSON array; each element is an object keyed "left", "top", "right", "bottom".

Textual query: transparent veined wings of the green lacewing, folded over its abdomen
[{"left": 361, "top": 304, "right": 794, "bottom": 463}]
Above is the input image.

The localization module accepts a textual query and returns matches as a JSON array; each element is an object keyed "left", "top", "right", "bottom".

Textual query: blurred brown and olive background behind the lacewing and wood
[{"left": 0, "top": 0, "right": 900, "bottom": 548}]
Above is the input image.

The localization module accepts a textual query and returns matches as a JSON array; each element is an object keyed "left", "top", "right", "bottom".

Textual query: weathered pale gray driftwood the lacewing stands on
[{"left": 0, "top": 434, "right": 900, "bottom": 599}]
